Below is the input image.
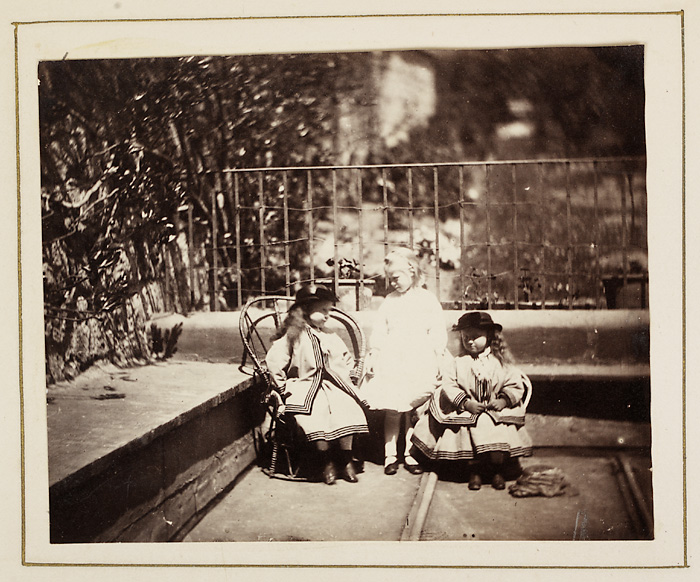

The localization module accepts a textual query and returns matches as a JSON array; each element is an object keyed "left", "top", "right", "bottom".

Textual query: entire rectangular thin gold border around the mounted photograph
[{"left": 12, "top": 10, "right": 689, "bottom": 570}]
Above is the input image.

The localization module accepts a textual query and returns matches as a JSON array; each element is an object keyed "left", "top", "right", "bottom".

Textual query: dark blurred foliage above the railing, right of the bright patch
[{"left": 386, "top": 45, "right": 646, "bottom": 162}]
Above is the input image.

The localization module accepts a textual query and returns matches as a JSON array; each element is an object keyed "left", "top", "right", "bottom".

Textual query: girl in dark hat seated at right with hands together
[{"left": 412, "top": 311, "right": 532, "bottom": 490}]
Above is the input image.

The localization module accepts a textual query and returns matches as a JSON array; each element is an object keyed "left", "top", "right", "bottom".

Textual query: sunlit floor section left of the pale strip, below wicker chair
[{"left": 184, "top": 463, "right": 420, "bottom": 542}]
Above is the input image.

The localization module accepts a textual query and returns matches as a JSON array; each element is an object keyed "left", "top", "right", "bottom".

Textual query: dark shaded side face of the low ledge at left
[{"left": 49, "top": 364, "right": 264, "bottom": 543}]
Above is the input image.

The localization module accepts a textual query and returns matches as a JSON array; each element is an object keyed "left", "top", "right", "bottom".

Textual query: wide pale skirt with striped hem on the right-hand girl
[{"left": 411, "top": 414, "right": 532, "bottom": 461}]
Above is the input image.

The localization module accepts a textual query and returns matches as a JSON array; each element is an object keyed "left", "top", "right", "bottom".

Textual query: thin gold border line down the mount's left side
[{"left": 14, "top": 24, "right": 27, "bottom": 564}]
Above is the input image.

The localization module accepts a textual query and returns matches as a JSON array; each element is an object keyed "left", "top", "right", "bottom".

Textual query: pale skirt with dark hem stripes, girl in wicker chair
[{"left": 294, "top": 381, "right": 369, "bottom": 441}]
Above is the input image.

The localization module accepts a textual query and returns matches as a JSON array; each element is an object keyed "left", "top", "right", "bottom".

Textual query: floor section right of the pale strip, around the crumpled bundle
[{"left": 421, "top": 449, "right": 651, "bottom": 541}]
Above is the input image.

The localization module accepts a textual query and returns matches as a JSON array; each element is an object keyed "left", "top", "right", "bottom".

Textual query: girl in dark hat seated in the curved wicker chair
[{"left": 265, "top": 285, "right": 368, "bottom": 485}]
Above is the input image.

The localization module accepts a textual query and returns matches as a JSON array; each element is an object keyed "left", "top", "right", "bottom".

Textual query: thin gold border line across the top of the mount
[{"left": 12, "top": 10, "right": 683, "bottom": 26}]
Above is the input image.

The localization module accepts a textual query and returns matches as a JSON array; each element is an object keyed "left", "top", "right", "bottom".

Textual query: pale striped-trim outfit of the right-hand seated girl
[{"left": 412, "top": 348, "right": 532, "bottom": 461}]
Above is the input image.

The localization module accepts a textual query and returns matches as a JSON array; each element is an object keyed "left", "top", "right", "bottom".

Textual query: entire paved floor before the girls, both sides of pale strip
[{"left": 184, "top": 449, "right": 651, "bottom": 542}]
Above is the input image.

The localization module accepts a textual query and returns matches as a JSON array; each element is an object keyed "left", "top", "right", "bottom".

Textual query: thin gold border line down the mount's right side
[{"left": 681, "top": 10, "right": 688, "bottom": 567}]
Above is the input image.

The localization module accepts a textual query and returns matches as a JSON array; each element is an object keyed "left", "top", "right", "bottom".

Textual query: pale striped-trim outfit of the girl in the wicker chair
[{"left": 265, "top": 326, "right": 369, "bottom": 441}]
